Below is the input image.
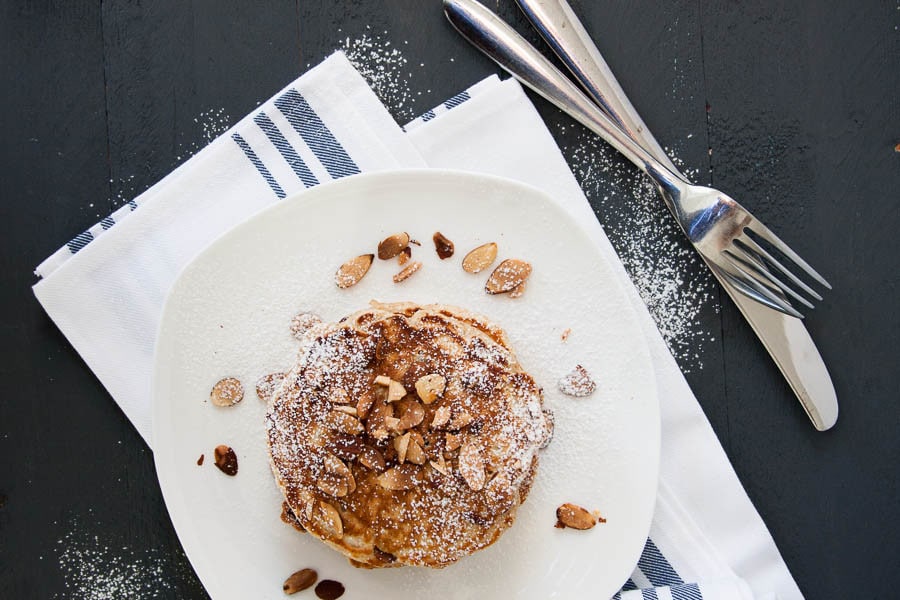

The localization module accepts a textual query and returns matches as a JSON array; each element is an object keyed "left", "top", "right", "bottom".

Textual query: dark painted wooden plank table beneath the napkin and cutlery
[{"left": 0, "top": 0, "right": 900, "bottom": 599}]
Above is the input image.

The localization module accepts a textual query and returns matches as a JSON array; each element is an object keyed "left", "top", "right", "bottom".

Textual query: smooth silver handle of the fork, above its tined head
[{"left": 444, "top": 0, "right": 687, "bottom": 202}]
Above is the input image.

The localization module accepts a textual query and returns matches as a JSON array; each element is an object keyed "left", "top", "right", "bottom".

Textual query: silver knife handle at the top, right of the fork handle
[{"left": 516, "top": 0, "right": 680, "bottom": 173}]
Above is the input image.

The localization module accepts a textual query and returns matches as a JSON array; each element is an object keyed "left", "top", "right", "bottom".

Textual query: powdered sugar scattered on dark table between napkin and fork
[{"left": 558, "top": 124, "right": 718, "bottom": 372}]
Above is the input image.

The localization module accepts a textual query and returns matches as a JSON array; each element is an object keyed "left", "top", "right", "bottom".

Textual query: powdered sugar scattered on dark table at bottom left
[{"left": 54, "top": 521, "right": 206, "bottom": 600}]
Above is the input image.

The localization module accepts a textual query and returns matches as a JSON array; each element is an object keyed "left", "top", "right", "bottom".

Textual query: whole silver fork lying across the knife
[{"left": 444, "top": 0, "right": 831, "bottom": 318}]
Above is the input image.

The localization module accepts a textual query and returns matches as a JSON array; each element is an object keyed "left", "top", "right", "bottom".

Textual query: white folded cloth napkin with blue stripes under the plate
[{"left": 34, "top": 53, "right": 803, "bottom": 600}]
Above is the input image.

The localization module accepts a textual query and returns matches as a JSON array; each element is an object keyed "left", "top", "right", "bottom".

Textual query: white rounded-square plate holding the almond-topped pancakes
[{"left": 153, "top": 170, "right": 660, "bottom": 600}]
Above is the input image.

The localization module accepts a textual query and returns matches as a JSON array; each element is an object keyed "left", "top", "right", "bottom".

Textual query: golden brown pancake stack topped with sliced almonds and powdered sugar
[{"left": 266, "top": 303, "right": 552, "bottom": 567}]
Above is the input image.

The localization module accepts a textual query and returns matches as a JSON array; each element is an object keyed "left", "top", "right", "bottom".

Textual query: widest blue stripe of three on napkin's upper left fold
[{"left": 275, "top": 90, "right": 359, "bottom": 179}]
